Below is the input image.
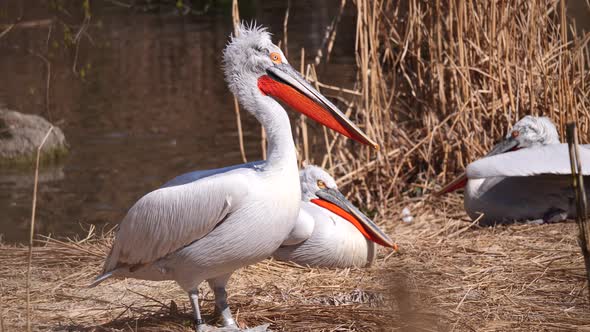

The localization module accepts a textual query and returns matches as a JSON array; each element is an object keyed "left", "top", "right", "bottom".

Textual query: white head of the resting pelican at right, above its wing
[{"left": 486, "top": 115, "right": 560, "bottom": 157}]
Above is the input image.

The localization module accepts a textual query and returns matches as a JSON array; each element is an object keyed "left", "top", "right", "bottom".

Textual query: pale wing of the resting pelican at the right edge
[{"left": 467, "top": 144, "right": 590, "bottom": 179}]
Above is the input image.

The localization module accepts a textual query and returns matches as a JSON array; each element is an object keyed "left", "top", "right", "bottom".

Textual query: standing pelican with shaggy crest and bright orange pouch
[{"left": 93, "top": 25, "right": 378, "bottom": 331}]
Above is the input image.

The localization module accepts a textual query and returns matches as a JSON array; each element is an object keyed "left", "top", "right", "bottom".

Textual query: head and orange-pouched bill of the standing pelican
[{"left": 223, "top": 24, "right": 379, "bottom": 149}]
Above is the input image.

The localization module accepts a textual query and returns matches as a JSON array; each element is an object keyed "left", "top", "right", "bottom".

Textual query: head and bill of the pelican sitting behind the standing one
[{"left": 299, "top": 165, "right": 397, "bottom": 249}]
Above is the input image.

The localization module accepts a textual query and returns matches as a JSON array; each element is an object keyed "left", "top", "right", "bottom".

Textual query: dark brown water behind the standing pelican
[{"left": 0, "top": 1, "right": 355, "bottom": 242}]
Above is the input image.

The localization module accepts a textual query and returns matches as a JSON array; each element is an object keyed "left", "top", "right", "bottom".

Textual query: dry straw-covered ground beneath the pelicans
[{"left": 0, "top": 196, "right": 590, "bottom": 331}]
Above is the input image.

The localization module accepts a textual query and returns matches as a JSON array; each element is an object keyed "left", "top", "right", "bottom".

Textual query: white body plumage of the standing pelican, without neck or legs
[{"left": 106, "top": 163, "right": 301, "bottom": 291}]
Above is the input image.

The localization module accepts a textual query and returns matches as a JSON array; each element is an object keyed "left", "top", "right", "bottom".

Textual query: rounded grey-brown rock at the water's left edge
[{"left": 0, "top": 108, "right": 68, "bottom": 165}]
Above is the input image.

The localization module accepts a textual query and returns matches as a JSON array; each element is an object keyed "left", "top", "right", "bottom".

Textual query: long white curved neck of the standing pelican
[{"left": 238, "top": 81, "right": 297, "bottom": 170}]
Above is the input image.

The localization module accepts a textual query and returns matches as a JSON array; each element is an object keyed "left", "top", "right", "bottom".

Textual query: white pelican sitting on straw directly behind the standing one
[{"left": 273, "top": 165, "right": 396, "bottom": 267}]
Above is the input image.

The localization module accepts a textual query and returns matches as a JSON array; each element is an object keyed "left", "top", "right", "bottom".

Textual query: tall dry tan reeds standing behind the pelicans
[{"left": 300, "top": 0, "right": 590, "bottom": 213}]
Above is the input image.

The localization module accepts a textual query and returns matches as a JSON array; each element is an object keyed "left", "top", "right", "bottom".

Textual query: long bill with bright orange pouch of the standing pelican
[{"left": 258, "top": 63, "right": 379, "bottom": 149}]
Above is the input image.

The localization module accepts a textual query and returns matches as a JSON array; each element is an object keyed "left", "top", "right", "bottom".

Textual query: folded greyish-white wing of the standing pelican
[{"left": 104, "top": 169, "right": 249, "bottom": 272}]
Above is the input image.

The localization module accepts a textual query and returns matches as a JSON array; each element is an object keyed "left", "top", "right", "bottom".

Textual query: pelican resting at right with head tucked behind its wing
[{"left": 439, "top": 115, "right": 590, "bottom": 225}]
